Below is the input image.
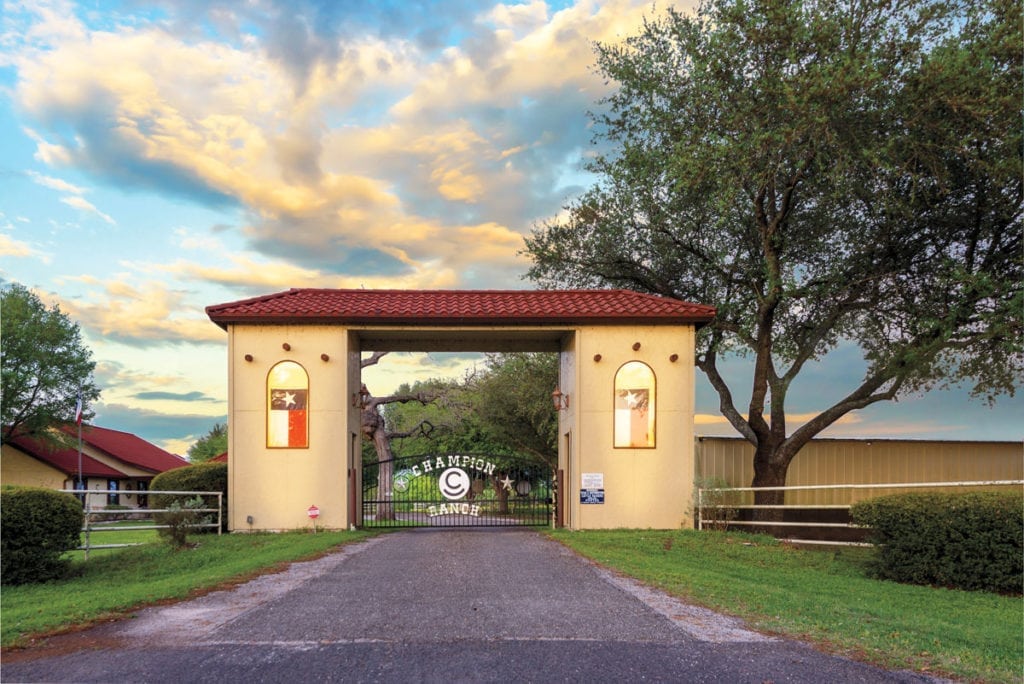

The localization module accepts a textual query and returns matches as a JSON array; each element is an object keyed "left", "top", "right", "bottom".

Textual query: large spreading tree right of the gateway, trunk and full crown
[{"left": 526, "top": 0, "right": 1024, "bottom": 511}]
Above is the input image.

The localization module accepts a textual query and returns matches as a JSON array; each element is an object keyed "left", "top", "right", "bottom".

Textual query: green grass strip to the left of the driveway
[{"left": 0, "top": 531, "right": 373, "bottom": 647}]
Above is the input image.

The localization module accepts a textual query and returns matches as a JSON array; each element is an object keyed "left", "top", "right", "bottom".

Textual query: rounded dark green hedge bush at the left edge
[{"left": 0, "top": 485, "right": 85, "bottom": 585}]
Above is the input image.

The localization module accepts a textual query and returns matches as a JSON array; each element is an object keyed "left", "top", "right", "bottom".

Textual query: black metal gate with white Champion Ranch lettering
[{"left": 362, "top": 454, "right": 556, "bottom": 527}]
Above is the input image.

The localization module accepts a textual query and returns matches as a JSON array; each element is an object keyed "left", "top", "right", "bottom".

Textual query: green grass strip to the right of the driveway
[{"left": 550, "top": 530, "right": 1024, "bottom": 682}]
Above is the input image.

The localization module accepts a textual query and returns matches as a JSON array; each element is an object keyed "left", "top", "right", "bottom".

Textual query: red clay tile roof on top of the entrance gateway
[{"left": 206, "top": 289, "right": 715, "bottom": 330}]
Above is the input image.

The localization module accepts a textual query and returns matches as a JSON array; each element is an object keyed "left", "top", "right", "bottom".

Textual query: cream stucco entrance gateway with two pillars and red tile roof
[{"left": 206, "top": 289, "right": 715, "bottom": 531}]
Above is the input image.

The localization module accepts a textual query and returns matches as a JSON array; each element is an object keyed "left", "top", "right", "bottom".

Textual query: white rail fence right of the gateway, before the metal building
[{"left": 697, "top": 480, "right": 1024, "bottom": 546}]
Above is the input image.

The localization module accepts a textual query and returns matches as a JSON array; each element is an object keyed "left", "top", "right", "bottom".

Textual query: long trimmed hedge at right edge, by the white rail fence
[{"left": 850, "top": 491, "right": 1024, "bottom": 594}]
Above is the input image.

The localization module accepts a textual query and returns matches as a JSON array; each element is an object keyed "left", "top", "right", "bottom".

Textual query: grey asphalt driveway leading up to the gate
[{"left": 0, "top": 528, "right": 935, "bottom": 684}]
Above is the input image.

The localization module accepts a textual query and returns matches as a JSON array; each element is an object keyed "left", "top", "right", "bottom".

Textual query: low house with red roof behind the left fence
[{"left": 0, "top": 425, "right": 188, "bottom": 508}]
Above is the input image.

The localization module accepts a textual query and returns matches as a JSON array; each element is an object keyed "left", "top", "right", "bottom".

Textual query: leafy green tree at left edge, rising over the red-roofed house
[{"left": 0, "top": 283, "right": 99, "bottom": 441}]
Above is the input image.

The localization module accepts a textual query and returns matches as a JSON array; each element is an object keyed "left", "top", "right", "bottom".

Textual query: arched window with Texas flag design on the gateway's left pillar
[{"left": 266, "top": 361, "right": 309, "bottom": 448}]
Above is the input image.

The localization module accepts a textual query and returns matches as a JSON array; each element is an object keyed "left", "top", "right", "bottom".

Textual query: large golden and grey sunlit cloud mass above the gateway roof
[{"left": 6, "top": 0, "right": 688, "bottom": 292}]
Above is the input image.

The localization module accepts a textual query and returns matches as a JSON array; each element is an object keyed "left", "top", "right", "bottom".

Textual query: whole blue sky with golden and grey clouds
[{"left": 0, "top": 0, "right": 1024, "bottom": 454}]
